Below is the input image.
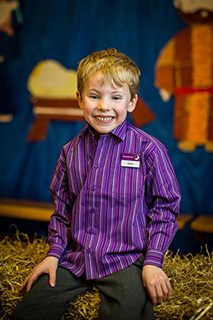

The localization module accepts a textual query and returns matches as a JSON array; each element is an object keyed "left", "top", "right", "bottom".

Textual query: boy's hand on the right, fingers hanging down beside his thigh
[{"left": 142, "top": 265, "right": 172, "bottom": 306}]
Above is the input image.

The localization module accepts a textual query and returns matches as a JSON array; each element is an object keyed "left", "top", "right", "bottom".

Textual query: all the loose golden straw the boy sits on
[{"left": 0, "top": 233, "right": 213, "bottom": 320}]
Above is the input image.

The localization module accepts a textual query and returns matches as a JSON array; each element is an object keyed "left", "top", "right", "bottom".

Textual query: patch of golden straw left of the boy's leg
[{"left": 0, "top": 232, "right": 49, "bottom": 320}]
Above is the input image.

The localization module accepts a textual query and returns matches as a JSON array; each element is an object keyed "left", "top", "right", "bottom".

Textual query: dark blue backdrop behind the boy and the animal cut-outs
[{"left": 0, "top": 0, "right": 213, "bottom": 238}]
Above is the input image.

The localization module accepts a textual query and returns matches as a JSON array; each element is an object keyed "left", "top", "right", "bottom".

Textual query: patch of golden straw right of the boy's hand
[{"left": 155, "top": 247, "right": 213, "bottom": 320}]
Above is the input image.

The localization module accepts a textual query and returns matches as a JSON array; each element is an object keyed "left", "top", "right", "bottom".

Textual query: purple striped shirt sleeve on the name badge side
[{"left": 144, "top": 145, "right": 181, "bottom": 268}]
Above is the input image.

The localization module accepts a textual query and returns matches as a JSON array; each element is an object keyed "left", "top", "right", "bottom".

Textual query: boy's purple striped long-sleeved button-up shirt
[{"left": 47, "top": 121, "right": 180, "bottom": 279}]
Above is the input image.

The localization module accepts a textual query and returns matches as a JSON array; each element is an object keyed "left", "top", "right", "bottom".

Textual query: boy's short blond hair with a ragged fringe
[{"left": 77, "top": 49, "right": 140, "bottom": 99}]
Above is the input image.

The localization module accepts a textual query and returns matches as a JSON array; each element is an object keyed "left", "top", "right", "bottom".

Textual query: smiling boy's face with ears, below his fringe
[{"left": 77, "top": 72, "right": 138, "bottom": 135}]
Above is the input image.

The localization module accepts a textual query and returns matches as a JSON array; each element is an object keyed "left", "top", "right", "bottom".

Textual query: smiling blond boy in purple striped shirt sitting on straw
[{"left": 12, "top": 49, "right": 180, "bottom": 320}]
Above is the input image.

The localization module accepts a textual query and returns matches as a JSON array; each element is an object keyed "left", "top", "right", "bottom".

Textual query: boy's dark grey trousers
[{"left": 11, "top": 257, "right": 155, "bottom": 320}]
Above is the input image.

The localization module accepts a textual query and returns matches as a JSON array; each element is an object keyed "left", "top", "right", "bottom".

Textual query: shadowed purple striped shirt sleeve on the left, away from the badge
[{"left": 46, "top": 149, "right": 73, "bottom": 260}]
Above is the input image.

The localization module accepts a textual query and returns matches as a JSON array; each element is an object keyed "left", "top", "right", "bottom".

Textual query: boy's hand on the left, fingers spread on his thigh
[{"left": 20, "top": 257, "right": 58, "bottom": 292}]
